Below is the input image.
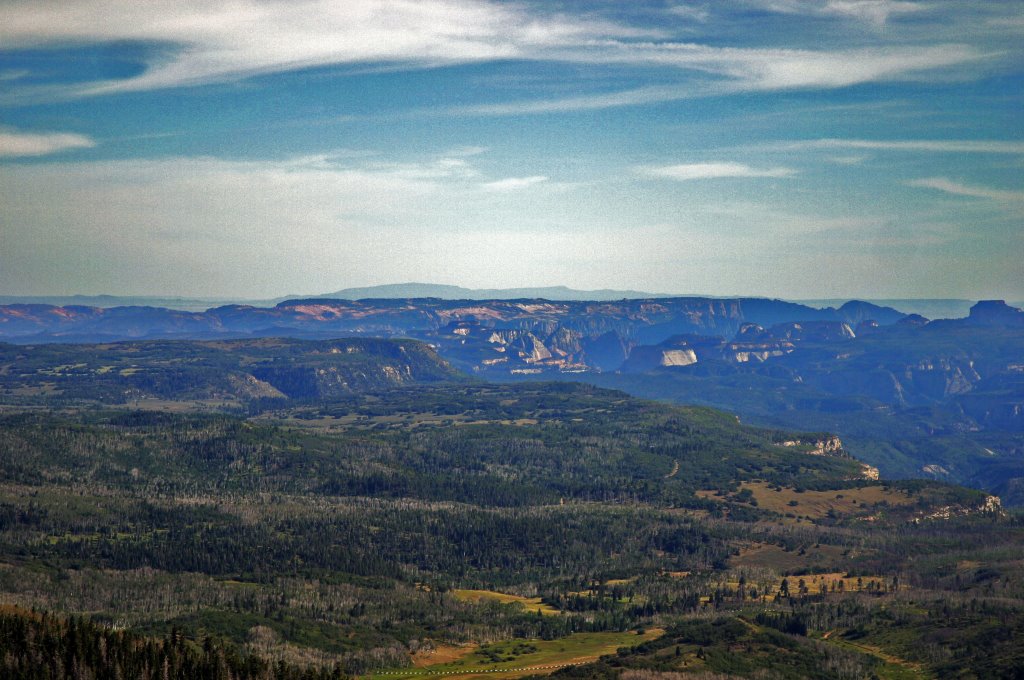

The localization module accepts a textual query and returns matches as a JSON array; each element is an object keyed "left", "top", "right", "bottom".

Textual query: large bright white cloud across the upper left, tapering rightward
[{"left": 0, "top": 0, "right": 630, "bottom": 93}]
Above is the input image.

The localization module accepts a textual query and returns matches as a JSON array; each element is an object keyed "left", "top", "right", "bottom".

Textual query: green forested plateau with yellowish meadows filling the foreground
[{"left": 0, "top": 344, "right": 1024, "bottom": 680}]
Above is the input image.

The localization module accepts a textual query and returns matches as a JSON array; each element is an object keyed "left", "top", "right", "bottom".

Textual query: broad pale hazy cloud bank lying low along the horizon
[{"left": 0, "top": 154, "right": 1020, "bottom": 297}]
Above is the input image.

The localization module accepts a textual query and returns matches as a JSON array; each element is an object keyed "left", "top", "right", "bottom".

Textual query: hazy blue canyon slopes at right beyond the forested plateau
[{"left": 574, "top": 311, "right": 1024, "bottom": 505}]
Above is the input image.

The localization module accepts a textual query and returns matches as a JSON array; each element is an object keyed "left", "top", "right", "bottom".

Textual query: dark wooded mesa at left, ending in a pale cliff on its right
[{"left": 0, "top": 338, "right": 457, "bottom": 405}]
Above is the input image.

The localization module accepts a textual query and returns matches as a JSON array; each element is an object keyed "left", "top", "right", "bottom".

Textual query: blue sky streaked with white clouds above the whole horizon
[{"left": 0, "top": 0, "right": 1024, "bottom": 300}]
